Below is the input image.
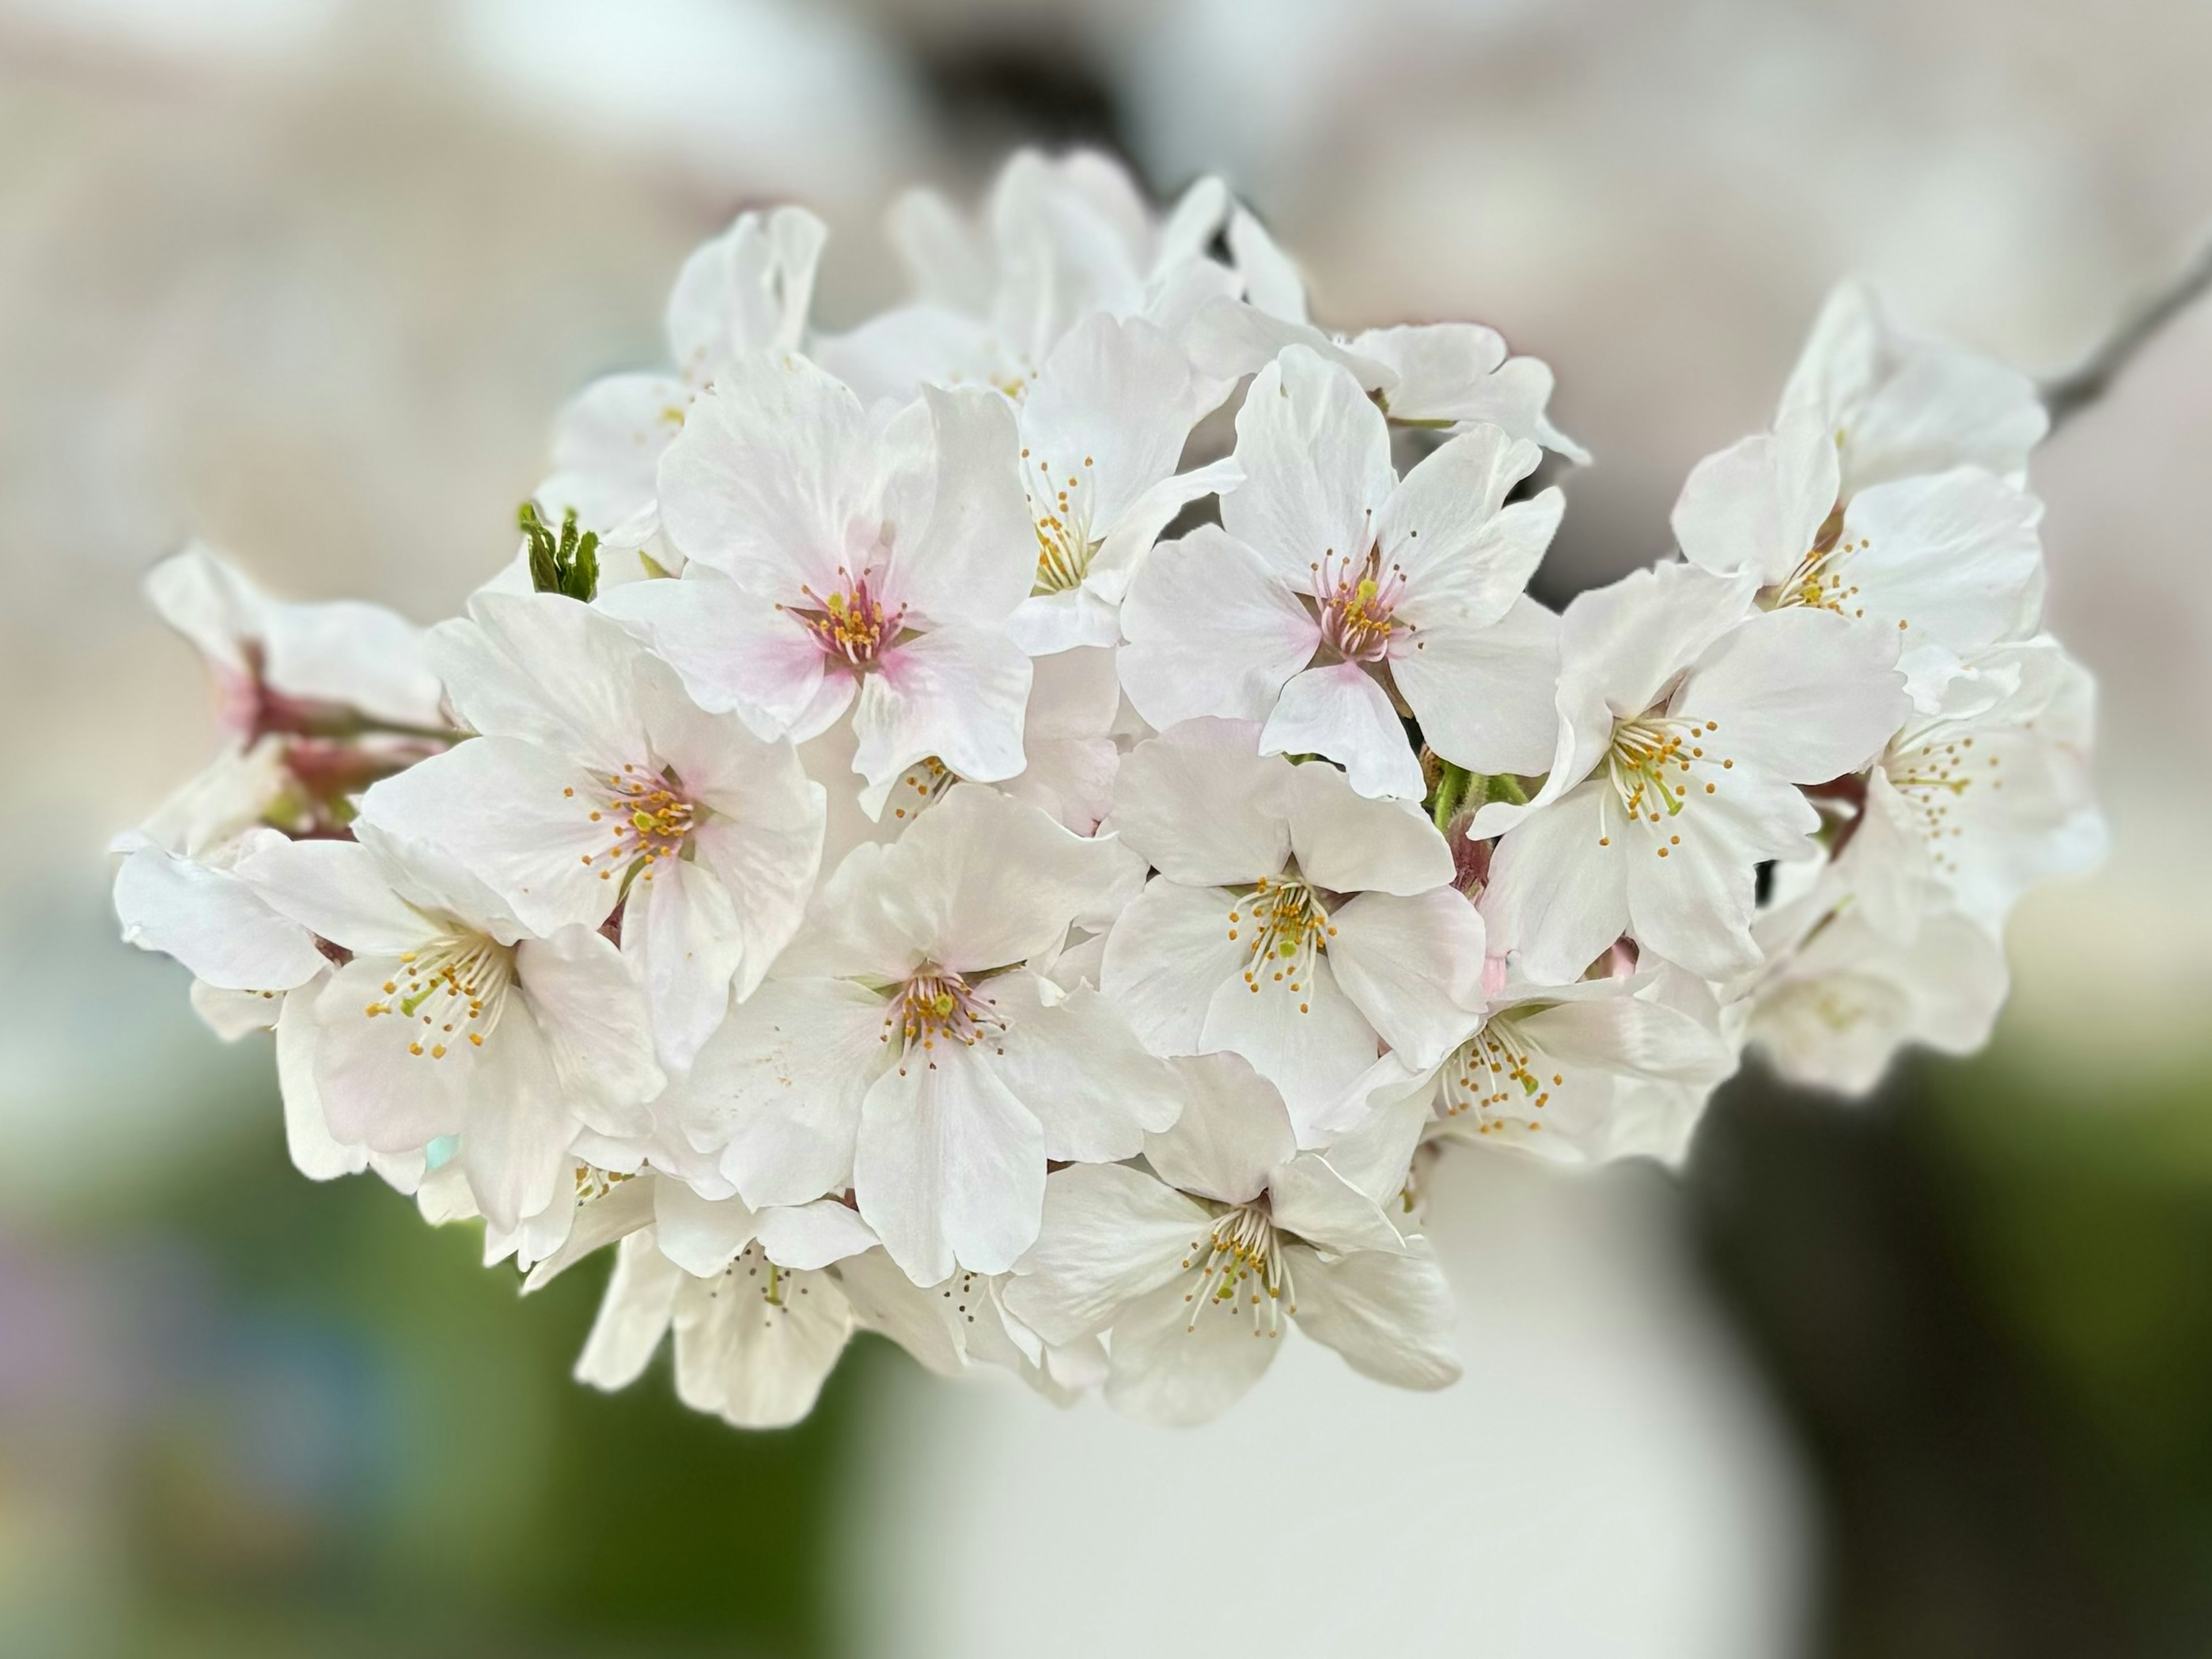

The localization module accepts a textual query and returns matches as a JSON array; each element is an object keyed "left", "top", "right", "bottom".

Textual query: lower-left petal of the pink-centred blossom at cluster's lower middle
[{"left": 679, "top": 980, "right": 889, "bottom": 1208}]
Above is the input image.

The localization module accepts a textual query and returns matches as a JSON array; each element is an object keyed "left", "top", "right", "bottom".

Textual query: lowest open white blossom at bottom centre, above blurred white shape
[{"left": 1006, "top": 1055, "right": 1460, "bottom": 1422}]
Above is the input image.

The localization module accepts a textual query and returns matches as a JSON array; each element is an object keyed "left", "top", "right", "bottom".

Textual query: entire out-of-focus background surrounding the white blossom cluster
[{"left": 0, "top": 0, "right": 2212, "bottom": 1659}]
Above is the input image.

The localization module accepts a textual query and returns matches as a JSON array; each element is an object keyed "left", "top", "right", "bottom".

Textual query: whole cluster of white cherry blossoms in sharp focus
[{"left": 115, "top": 153, "right": 2101, "bottom": 1425}]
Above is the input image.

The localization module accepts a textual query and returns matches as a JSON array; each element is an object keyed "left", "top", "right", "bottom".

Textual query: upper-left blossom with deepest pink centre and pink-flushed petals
[{"left": 601, "top": 356, "right": 1037, "bottom": 808}]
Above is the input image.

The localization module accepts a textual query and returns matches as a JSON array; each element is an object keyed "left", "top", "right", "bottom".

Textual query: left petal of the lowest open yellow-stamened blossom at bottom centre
[{"left": 1006, "top": 1164, "right": 1212, "bottom": 1345}]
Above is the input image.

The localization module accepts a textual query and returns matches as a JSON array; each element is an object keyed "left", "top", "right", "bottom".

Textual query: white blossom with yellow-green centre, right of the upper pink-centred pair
[{"left": 1471, "top": 564, "right": 1904, "bottom": 984}]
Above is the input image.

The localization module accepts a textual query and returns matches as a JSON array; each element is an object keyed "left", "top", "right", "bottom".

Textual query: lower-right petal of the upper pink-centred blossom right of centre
[{"left": 1391, "top": 595, "right": 1559, "bottom": 777}]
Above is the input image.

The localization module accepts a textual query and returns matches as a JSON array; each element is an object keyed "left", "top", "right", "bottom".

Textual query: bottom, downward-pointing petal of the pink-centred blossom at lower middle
[{"left": 851, "top": 1042, "right": 1044, "bottom": 1285}]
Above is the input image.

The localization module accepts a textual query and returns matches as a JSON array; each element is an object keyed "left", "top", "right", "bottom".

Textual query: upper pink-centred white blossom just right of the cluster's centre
[{"left": 1122, "top": 347, "right": 1562, "bottom": 798}]
